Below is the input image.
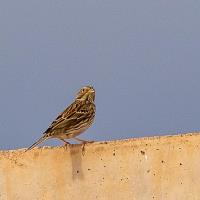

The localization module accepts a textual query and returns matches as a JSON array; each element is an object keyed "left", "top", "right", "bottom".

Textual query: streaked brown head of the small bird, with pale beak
[{"left": 76, "top": 86, "right": 95, "bottom": 103}]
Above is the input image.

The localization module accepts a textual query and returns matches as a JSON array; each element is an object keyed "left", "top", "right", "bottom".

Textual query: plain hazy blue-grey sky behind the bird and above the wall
[{"left": 0, "top": 0, "right": 200, "bottom": 149}]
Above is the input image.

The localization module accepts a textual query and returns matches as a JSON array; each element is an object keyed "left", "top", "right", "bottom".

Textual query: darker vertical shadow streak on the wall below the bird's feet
[{"left": 70, "top": 144, "right": 84, "bottom": 180}]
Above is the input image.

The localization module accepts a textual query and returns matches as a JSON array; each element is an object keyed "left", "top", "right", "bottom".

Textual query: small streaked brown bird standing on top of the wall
[{"left": 25, "top": 86, "right": 96, "bottom": 151}]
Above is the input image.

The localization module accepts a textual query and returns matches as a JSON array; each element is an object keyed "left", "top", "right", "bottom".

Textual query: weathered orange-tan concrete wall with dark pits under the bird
[{"left": 0, "top": 134, "right": 200, "bottom": 200}]
